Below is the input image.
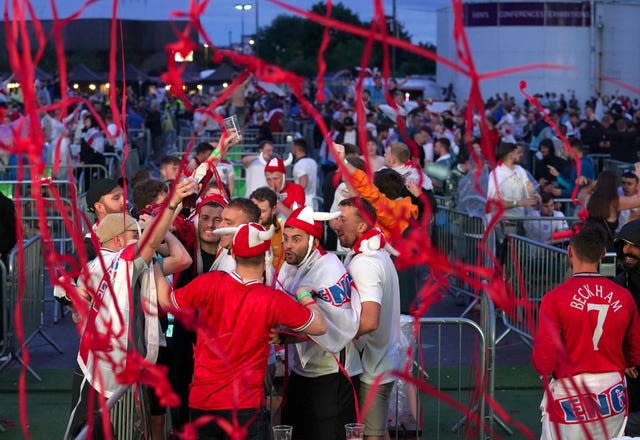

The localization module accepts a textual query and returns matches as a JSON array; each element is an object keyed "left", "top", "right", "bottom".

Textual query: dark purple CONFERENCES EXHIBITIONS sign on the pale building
[{"left": 464, "top": 2, "right": 591, "bottom": 27}]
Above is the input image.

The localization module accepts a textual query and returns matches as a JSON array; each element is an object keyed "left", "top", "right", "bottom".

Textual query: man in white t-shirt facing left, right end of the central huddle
[{"left": 332, "top": 197, "right": 401, "bottom": 440}]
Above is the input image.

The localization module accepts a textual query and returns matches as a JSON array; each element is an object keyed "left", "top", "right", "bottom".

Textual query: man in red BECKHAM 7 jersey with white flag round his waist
[{"left": 532, "top": 225, "right": 640, "bottom": 440}]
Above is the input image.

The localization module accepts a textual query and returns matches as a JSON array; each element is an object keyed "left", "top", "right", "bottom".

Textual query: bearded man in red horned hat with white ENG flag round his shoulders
[{"left": 273, "top": 206, "right": 362, "bottom": 440}]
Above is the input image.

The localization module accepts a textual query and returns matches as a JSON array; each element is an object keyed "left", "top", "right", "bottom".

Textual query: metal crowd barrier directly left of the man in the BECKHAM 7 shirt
[{"left": 496, "top": 235, "right": 570, "bottom": 346}]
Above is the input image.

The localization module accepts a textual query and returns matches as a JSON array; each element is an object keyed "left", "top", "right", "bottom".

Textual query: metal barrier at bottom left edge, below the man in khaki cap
[{"left": 75, "top": 385, "right": 151, "bottom": 440}]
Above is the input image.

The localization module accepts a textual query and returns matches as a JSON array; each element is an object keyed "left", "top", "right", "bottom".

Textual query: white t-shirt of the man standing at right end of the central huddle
[{"left": 345, "top": 250, "right": 403, "bottom": 384}]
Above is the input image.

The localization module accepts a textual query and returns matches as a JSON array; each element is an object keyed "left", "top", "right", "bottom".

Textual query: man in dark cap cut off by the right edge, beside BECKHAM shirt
[{"left": 614, "top": 220, "right": 640, "bottom": 437}]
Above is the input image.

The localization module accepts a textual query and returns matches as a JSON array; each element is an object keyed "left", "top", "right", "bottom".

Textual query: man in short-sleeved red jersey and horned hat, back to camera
[{"left": 158, "top": 223, "right": 327, "bottom": 439}]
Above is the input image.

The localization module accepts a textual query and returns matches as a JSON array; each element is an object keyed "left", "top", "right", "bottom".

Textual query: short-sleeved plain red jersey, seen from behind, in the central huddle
[{"left": 172, "top": 271, "right": 313, "bottom": 410}]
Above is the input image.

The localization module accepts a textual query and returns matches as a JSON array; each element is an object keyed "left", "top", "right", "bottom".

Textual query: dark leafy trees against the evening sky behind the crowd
[{"left": 257, "top": 2, "right": 435, "bottom": 76}]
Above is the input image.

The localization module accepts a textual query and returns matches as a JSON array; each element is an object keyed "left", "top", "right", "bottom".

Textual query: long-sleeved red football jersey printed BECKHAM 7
[{"left": 532, "top": 273, "right": 640, "bottom": 379}]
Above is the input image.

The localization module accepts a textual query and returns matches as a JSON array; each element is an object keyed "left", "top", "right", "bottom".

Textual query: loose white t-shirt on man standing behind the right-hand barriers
[{"left": 487, "top": 164, "right": 529, "bottom": 217}]
